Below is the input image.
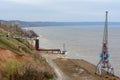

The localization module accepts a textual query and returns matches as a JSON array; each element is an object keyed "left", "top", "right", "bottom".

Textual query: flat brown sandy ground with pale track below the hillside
[{"left": 41, "top": 53, "right": 120, "bottom": 80}]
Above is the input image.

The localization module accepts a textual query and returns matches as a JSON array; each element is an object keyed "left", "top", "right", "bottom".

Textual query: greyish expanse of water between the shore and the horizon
[{"left": 30, "top": 25, "right": 120, "bottom": 76}]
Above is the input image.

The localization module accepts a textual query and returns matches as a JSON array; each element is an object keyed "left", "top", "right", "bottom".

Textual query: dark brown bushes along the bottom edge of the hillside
[{"left": 9, "top": 67, "right": 53, "bottom": 80}]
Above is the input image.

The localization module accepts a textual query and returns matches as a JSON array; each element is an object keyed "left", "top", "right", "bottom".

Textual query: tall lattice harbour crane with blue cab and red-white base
[{"left": 96, "top": 11, "right": 114, "bottom": 76}]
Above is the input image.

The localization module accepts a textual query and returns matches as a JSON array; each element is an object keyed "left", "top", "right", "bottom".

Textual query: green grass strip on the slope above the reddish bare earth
[{"left": 0, "top": 37, "right": 32, "bottom": 55}]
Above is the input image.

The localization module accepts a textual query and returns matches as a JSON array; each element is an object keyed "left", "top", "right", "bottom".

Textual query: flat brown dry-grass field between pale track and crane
[{"left": 54, "top": 58, "right": 120, "bottom": 80}]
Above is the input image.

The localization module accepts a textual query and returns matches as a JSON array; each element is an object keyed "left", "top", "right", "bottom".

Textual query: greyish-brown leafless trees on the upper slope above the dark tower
[{"left": 0, "top": 21, "right": 38, "bottom": 38}]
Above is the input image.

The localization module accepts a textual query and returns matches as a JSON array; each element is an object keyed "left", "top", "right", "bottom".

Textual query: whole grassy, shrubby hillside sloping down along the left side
[{"left": 0, "top": 22, "right": 53, "bottom": 80}]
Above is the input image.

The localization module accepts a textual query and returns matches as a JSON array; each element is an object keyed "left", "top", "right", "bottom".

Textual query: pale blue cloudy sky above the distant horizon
[{"left": 0, "top": 0, "right": 120, "bottom": 22}]
